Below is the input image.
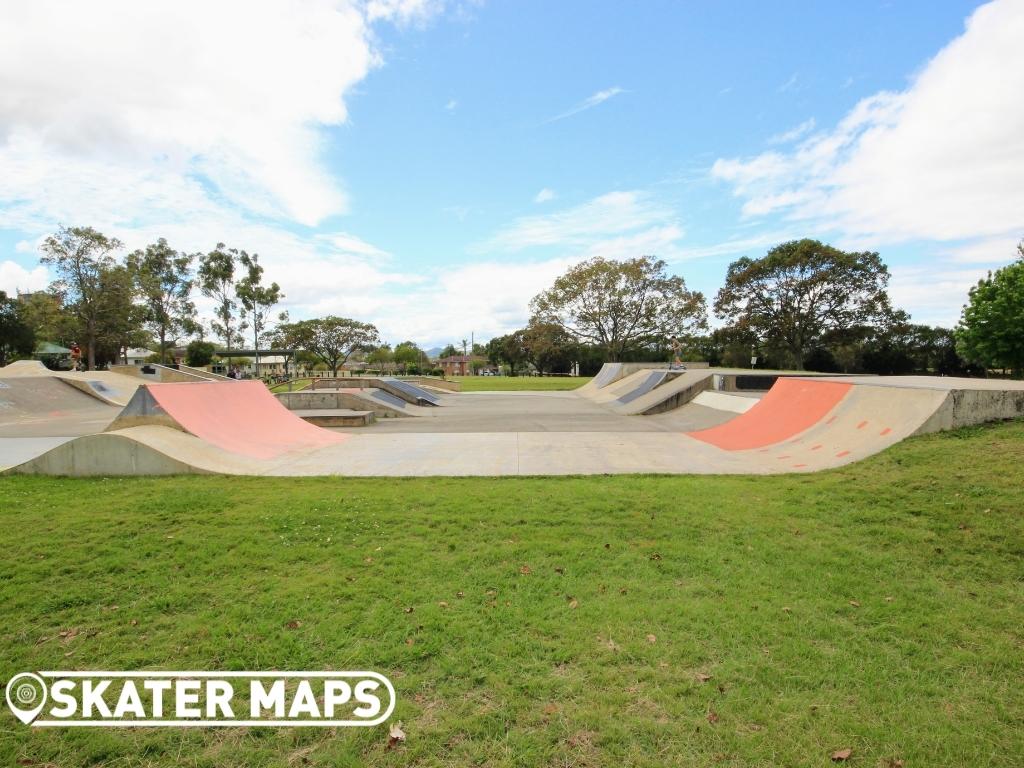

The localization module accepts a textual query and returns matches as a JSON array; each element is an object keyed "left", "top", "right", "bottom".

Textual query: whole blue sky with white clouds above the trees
[{"left": 0, "top": 0, "right": 1024, "bottom": 346}]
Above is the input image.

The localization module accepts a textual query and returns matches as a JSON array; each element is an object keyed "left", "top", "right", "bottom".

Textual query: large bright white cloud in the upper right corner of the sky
[{"left": 712, "top": 0, "right": 1024, "bottom": 244}]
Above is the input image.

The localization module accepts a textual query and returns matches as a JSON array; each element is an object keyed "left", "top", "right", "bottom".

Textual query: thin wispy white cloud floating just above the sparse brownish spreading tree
[{"left": 471, "top": 190, "right": 682, "bottom": 255}]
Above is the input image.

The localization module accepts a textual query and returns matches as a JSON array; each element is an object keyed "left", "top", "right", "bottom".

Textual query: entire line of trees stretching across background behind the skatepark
[{"left": 0, "top": 227, "right": 1024, "bottom": 376}]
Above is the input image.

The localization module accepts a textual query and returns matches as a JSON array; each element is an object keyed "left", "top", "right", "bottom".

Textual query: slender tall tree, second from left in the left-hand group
[{"left": 128, "top": 238, "right": 197, "bottom": 362}]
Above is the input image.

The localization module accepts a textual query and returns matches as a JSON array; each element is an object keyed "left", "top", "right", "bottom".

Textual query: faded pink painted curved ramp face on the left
[{"left": 147, "top": 381, "right": 346, "bottom": 459}]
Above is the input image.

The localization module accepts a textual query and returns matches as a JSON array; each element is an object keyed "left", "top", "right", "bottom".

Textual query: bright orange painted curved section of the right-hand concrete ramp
[{"left": 687, "top": 378, "right": 853, "bottom": 451}]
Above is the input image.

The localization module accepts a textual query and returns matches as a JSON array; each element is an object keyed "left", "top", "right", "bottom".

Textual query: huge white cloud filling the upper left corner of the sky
[{"left": 0, "top": 0, "right": 452, "bottom": 226}]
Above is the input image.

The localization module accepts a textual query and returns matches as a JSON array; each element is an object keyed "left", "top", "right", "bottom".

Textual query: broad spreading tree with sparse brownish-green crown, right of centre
[{"left": 529, "top": 256, "right": 707, "bottom": 360}]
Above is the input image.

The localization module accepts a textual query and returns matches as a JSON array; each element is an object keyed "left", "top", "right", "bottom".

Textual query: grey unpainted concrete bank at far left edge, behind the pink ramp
[{"left": 0, "top": 376, "right": 118, "bottom": 437}]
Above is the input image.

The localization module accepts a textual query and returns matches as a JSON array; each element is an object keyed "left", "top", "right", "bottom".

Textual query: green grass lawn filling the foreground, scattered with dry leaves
[{"left": 0, "top": 423, "right": 1024, "bottom": 768}]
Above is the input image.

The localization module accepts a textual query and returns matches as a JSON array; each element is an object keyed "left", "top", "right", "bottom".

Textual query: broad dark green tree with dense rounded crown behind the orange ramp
[{"left": 715, "top": 240, "right": 890, "bottom": 370}]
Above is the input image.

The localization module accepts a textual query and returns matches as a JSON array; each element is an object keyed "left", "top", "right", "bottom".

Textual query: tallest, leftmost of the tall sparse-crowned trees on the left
[{"left": 40, "top": 226, "right": 126, "bottom": 371}]
